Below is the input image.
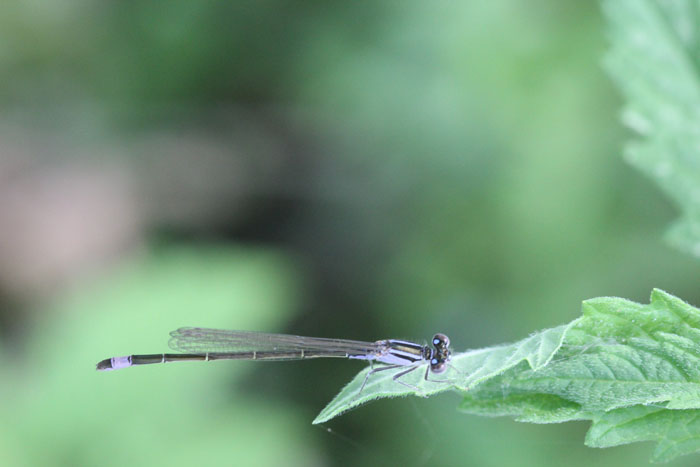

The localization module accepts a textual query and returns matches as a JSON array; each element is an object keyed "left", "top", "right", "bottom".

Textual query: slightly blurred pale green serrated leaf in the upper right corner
[{"left": 603, "top": 0, "right": 700, "bottom": 257}]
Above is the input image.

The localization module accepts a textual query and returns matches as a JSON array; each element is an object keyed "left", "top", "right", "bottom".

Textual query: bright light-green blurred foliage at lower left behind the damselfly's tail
[{"left": 1, "top": 248, "right": 321, "bottom": 465}]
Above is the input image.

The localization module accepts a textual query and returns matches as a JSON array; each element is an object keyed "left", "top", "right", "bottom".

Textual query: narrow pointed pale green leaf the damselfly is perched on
[{"left": 313, "top": 321, "right": 576, "bottom": 423}]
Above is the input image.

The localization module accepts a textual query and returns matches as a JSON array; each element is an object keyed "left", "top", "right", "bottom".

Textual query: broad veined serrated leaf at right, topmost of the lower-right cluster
[{"left": 502, "top": 290, "right": 700, "bottom": 411}]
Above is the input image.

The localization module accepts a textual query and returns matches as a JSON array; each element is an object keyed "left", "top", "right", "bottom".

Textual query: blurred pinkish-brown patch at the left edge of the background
[{"left": 0, "top": 140, "right": 142, "bottom": 302}]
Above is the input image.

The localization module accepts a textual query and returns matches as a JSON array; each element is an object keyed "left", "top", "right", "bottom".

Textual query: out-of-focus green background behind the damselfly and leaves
[{"left": 0, "top": 0, "right": 700, "bottom": 466}]
